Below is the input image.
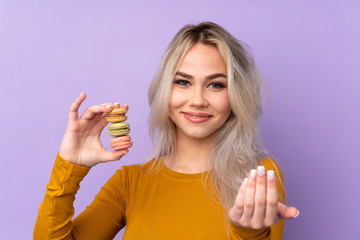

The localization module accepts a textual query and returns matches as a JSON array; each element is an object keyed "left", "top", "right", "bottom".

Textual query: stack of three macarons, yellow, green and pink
[{"left": 106, "top": 108, "right": 132, "bottom": 151}]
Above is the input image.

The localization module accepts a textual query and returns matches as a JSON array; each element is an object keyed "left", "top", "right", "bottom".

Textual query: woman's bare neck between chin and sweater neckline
[{"left": 164, "top": 130, "right": 214, "bottom": 174}]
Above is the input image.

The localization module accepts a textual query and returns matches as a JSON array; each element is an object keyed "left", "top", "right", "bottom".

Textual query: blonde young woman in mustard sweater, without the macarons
[{"left": 34, "top": 22, "right": 298, "bottom": 240}]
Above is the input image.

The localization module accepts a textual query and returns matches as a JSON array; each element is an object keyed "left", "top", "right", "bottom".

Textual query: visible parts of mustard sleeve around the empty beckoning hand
[{"left": 230, "top": 158, "right": 285, "bottom": 240}]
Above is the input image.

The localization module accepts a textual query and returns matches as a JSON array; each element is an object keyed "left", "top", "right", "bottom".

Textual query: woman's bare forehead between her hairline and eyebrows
[{"left": 178, "top": 43, "right": 226, "bottom": 74}]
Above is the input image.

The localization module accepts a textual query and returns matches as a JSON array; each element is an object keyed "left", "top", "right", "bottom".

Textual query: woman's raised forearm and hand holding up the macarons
[{"left": 34, "top": 93, "right": 132, "bottom": 239}]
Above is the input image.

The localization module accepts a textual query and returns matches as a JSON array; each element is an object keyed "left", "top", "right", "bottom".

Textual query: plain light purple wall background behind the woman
[{"left": 0, "top": 0, "right": 360, "bottom": 240}]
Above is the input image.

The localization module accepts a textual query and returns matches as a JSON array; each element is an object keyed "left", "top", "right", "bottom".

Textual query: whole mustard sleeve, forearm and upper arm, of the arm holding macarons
[{"left": 34, "top": 154, "right": 127, "bottom": 240}]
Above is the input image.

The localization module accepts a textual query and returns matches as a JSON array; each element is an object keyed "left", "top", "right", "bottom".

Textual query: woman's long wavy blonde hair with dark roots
[{"left": 148, "top": 22, "right": 266, "bottom": 228}]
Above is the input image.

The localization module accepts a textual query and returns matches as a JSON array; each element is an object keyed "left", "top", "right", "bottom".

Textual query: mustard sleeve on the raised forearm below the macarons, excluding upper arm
[{"left": 33, "top": 154, "right": 90, "bottom": 239}]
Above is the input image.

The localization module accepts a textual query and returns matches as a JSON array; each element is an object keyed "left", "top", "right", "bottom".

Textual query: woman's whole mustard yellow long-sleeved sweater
[{"left": 34, "top": 154, "right": 285, "bottom": 240}]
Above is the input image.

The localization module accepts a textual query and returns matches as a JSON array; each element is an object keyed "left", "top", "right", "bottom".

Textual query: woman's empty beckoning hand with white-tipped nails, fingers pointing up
[{"left": 229, "top": 166, "right": 299, "bottom": 229}]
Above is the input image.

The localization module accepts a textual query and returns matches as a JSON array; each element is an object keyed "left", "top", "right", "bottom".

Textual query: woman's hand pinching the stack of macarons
[{"left": 60, "top": 93, "right": 129, "bottom": 167}]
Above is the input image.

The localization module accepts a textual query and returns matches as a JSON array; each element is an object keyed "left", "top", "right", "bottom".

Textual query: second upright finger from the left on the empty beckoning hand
[{"left": 241, "top": 169, "right": 256, "bottom": 223}]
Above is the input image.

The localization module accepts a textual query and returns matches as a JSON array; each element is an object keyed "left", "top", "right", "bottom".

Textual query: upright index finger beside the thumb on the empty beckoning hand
[{"left": 264, "top": 170, "right": 279, "bottom": 226}]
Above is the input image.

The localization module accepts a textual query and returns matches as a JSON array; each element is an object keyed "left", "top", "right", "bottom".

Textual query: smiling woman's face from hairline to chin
[{"left": 169, "top": 43, "right": 231, "bottom": 139}]
